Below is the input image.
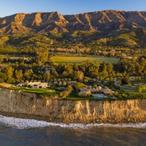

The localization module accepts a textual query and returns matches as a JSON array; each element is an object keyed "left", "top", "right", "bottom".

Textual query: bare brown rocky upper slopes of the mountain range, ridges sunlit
[{"left": 0, "top": 10, "right": 146, "bottom": 34}]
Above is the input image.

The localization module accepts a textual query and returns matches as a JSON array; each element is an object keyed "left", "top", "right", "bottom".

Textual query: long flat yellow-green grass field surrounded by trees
[{"left": 51, "top": 55, "right": 119, "bottom": 63}]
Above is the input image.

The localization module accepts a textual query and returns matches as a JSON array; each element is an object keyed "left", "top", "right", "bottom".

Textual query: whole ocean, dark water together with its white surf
[{"left": 0, "top": 115, "right": 146, "bottom": 146}]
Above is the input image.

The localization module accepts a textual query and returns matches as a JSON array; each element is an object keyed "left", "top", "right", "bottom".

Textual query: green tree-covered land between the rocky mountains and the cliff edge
[{"left": 0, "top": 30, "right": 146, "bottom": 98}]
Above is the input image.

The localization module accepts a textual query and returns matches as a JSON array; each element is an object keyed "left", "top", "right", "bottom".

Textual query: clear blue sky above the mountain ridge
[{"left": 0, "top": 0, "right": 146, "bottom": 17}]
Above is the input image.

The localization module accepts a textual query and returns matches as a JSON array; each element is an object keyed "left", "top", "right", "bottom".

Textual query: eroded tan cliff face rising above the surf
[{"left": 0, "top": 89, "right": 146, "bottom": 123}]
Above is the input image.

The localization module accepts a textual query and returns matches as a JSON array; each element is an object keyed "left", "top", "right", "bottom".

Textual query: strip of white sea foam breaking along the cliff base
[{"left": 0, "top": 115, "right": 146, "bottom": 129}]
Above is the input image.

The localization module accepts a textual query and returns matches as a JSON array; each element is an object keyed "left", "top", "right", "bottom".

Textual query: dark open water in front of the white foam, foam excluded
[{"left": 0, "top": 126, "right": 146, "bottom": 146}]
